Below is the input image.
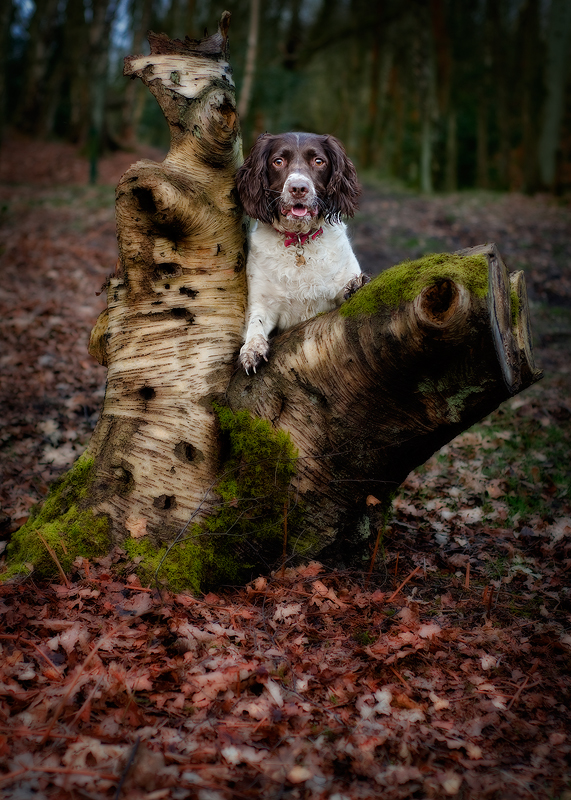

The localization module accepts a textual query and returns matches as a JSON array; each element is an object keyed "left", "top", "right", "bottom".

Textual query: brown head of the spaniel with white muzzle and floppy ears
[{"left": 236, "top": 133, "right": 360, "bottom": 232}]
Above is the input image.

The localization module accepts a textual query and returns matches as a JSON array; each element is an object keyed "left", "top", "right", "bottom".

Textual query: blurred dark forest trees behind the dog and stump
[{"left": 0, "top": 0, "right": 571, "bottom": 194}]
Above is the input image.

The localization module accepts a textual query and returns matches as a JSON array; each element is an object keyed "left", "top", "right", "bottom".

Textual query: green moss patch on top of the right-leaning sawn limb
[{"left": 339, "top": 253, "right": 488, "bottom": 317}]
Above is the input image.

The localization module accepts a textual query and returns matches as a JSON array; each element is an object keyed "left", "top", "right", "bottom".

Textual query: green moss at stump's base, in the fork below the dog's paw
[{"left": 132, "top": 405, "right": 301, "bottom": 592}]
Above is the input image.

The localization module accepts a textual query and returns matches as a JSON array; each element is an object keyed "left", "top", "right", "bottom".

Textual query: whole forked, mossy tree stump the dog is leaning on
[{"left": 4, "top": 20, "right": 539, "bottom": 591}]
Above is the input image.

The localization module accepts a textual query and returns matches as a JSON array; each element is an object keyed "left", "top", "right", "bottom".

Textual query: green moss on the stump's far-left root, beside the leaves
[{"left": 0, "top": 454, "right": 111, "bottom": 580}]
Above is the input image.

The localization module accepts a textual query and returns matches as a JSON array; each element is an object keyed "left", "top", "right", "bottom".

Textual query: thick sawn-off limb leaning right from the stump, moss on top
[{"left": 227, "top": 244, "right": 541, "bottom": 561}]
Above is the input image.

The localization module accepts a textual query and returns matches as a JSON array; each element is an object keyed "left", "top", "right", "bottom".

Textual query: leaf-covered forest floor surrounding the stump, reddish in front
[{"left": 0, "top": 134, "right": 571, "bottom": 800}]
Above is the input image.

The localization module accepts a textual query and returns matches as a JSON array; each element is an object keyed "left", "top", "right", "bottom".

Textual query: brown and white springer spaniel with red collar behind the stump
[{"left": 236, "top": 133, "right": 370, "bottom": 373}]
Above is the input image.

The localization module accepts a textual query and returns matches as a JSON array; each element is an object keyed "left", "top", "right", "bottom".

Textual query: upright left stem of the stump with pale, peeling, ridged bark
[{"left": 89, "top": 18, "right": 245, "bottom": 541}]
